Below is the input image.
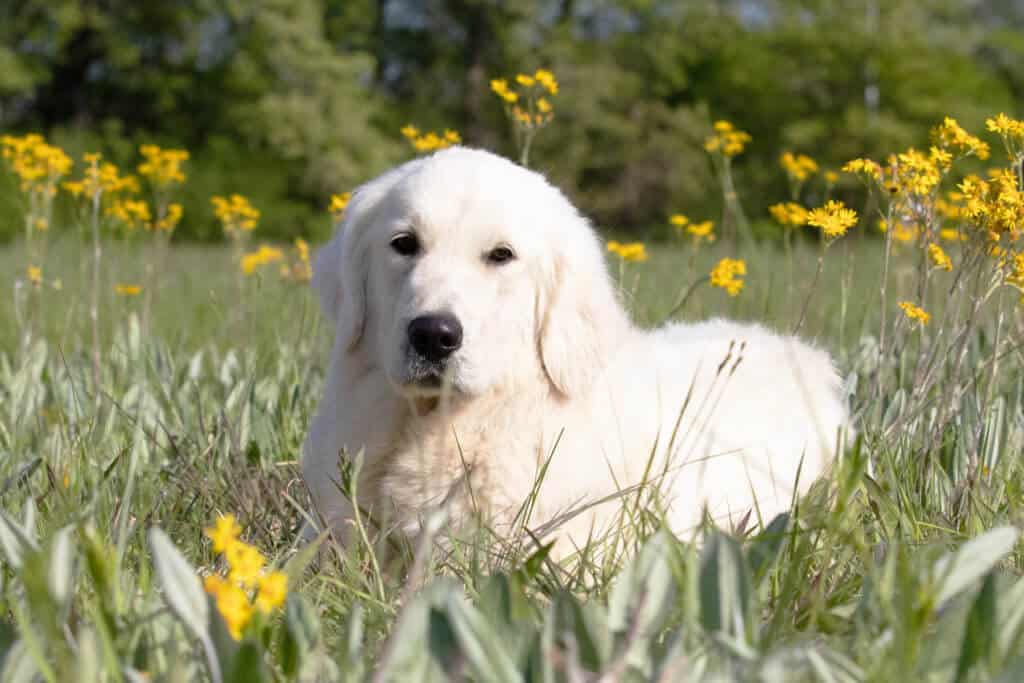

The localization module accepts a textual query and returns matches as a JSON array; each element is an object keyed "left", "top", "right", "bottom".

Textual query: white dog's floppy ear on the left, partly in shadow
[{"left": 312, "top": 160, "right": 420, "bottom": 350}]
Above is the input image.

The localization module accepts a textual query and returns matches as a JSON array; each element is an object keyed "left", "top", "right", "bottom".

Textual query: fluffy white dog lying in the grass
[{"left": 302, "top": 147, "right": 847, "bottom": 556}]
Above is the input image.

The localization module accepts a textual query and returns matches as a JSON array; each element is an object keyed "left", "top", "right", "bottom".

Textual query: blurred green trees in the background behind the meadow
[{"left": 0, "top": 0, "right": 1024, "bottom": 238}]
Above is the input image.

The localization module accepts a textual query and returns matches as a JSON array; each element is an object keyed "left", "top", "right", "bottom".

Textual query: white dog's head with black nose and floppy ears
[{"left": 313, "top": 147, "right": 629, "bottom": 397}]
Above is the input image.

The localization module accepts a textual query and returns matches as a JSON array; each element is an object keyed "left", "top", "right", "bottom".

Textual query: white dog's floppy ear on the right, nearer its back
[{"left": 538, "top": 215, "right": 631, "bottom": 397}]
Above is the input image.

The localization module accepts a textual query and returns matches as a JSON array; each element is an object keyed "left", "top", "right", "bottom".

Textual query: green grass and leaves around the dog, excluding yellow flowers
[{"left": 0, "top": 227, "right": 1024, "bottom": 681}]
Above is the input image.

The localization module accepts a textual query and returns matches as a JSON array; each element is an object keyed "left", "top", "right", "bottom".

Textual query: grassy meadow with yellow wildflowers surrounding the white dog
[{"left": 0, "top": 104, "right": 1024, "bottom": 682}]
